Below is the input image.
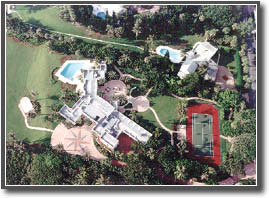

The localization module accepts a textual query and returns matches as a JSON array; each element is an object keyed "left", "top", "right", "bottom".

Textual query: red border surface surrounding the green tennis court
[{"left": 186, "top": 104, "right": 221, "bottom": 165}]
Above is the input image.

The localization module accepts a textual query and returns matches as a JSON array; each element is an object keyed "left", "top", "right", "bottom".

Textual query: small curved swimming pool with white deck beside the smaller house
[{"left": 156, "top": 46, "right": 184, "bottom": 63}]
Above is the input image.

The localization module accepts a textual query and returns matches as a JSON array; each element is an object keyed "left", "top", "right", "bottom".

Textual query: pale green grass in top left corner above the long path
[{"left": 16, "top": 5, "right": 84, "bottom": 36}]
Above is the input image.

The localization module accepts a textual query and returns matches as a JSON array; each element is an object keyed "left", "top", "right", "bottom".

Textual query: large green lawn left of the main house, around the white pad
[{"left": 6, "top": 40, "right": 64, "bottom": 142}]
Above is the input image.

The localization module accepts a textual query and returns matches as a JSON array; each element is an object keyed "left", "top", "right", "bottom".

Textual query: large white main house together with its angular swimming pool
[{"left": 56, "top": 60, "right": 152, "bottom": 150}]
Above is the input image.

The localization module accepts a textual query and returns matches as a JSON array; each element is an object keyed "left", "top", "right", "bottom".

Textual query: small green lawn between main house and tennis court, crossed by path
[{"left": 138, "top": 96, "right": 178, "bottom": 129}]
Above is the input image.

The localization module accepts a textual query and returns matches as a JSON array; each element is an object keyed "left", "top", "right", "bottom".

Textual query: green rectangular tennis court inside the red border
[{"left": 192, "top": 113, "right": 214, "bottom": 156}]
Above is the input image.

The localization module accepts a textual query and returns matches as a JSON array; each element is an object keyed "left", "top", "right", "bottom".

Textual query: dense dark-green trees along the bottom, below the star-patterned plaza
[{"left": 6, "top": 129, "right": 227, "bottom": 185}]
